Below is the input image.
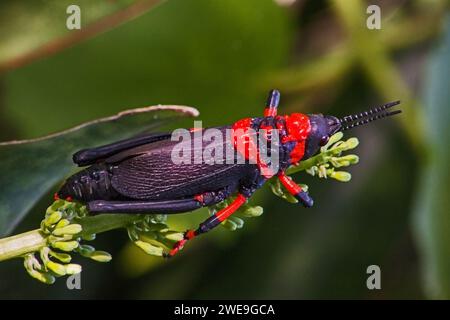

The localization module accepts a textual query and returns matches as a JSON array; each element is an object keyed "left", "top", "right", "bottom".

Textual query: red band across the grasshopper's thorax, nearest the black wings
[{"left": 231, "top": 118, "right": 275, "bottom": 178}]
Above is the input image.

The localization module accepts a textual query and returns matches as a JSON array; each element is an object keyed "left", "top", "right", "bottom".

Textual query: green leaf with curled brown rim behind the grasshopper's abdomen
[{"left": 0, "top": 106, "right": 198, "bottom": 235}]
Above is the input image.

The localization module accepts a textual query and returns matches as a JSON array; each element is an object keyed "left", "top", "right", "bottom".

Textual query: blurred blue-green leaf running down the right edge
[{"left": 414, "top": 18, "right": 450, "bottom": 299}]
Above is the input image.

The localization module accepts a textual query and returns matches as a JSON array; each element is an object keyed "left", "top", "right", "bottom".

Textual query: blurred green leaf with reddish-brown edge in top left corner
[{"left": 0, "top": 0, "right": 158, "bottom": 69}]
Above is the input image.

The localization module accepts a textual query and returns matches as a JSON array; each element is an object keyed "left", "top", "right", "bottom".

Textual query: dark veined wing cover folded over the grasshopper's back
[{"left": 105, "top": 127, "right": 256, "bottom": 200}]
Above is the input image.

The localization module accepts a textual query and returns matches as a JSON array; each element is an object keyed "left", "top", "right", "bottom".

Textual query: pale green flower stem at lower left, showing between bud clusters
[{"left": 0, "top": 214, "right": 141, "bottom": 261}]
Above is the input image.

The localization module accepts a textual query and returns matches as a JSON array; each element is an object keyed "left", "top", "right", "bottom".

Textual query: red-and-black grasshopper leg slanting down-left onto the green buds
[{"left": 166, "top": 193, "right": 247, "bottom": 258}]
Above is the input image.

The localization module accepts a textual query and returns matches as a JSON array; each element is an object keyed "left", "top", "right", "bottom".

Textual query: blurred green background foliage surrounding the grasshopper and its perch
[{"left": 0, "top": 0, "right": 450, "bottom": 299}]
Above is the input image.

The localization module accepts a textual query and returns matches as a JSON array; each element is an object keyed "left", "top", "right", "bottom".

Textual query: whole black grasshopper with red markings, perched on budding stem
[{"left": 57, "top": 90, "right": 401, "bottom": 256}]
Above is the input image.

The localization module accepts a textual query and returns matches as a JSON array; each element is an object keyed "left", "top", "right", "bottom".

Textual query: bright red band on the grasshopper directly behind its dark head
[{"left": 278, "top": 113, "right": 311, "bottom": 164}]
